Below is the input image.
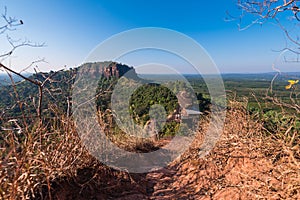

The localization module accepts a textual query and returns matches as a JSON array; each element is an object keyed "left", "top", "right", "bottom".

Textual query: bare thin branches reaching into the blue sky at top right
[{"left": 227, "top": 0, "right": 300, "bottom": 55}]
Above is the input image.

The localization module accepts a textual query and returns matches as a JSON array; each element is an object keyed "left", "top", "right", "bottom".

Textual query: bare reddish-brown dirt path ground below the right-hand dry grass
[{"left": 48, "top": 137, "right": 300, "bottom": 200}]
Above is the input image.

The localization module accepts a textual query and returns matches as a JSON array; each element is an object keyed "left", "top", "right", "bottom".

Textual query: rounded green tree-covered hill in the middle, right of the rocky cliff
[{"left": 96, "top": 67, "right": 210, "bottom": 136}]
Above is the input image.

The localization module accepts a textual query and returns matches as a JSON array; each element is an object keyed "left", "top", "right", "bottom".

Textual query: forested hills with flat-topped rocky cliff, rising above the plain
[{"left": 0, "top": 62, "right": 204, "bottom": 138}]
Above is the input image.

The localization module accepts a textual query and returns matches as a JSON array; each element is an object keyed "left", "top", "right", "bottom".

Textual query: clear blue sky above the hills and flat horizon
[{"left": 0, "top": 0, "right": 299, "bottom": 73}]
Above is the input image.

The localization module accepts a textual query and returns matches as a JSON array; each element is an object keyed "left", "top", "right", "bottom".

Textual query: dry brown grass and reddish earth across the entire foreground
[{"left": 0, "top": 102, "right": 300, "bottom": 199}]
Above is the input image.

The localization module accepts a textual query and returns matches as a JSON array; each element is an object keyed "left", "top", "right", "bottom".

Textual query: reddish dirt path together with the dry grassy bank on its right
[{"left": 45, "top": 108, "right": 300, "bottom": 200}]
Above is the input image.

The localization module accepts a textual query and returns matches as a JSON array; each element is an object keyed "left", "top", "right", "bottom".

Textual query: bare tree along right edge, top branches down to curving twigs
[{"left": 228, "top": 0, "right": 300, "bottom": 113}]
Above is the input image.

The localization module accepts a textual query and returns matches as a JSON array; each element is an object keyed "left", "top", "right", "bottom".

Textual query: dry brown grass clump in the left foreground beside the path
[{"left": 0, "top": 117, "right": 93, "bottom": 199}]
